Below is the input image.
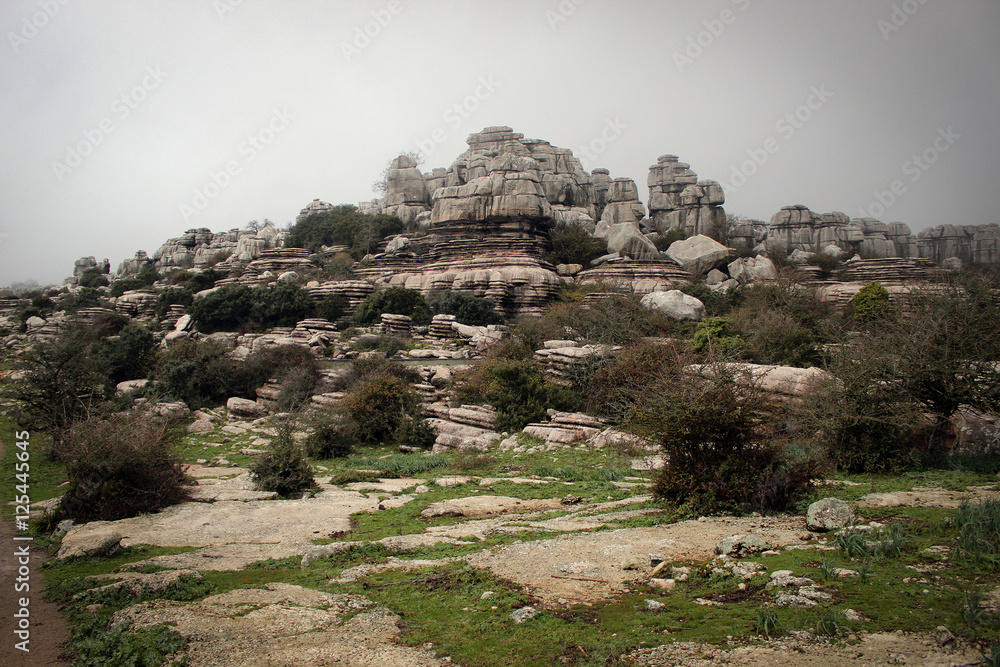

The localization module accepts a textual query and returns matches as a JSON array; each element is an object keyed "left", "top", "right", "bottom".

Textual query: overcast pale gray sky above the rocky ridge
[{"left": 0, "top": 0, "right": 1000, "bottom": 285}]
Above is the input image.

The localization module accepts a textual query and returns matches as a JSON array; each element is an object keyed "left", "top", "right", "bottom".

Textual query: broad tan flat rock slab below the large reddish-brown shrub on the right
[{"left": 467, "top": 517, "right": 803, "bottom": 605}]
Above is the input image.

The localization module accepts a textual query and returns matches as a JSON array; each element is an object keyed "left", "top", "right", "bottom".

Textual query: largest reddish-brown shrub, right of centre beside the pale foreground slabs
[{"left": 631, "top": 365, "right": 816, "bottom": 514}]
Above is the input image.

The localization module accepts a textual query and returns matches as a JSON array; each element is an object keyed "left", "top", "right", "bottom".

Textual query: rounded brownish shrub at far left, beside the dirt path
[{"left": 57, "top": 414, "right": 187, "bottom": 522}]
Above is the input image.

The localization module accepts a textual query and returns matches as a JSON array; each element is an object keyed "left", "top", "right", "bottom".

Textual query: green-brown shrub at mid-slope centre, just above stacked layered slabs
[{"left": 458, "top": 357, "right": 576, "bottom": 431}]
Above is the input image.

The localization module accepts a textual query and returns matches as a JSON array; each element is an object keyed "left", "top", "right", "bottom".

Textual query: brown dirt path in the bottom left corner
[{"left": 0, "top": 442, "right": 69, "bottom": 667}]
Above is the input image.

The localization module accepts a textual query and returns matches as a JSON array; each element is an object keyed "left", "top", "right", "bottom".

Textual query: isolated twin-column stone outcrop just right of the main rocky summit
[{"left": 647, "top": 155, "right": 726, "bottom": 238}]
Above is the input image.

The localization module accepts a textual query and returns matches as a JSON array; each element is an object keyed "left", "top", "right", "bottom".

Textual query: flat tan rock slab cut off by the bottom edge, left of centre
[{"left": 113, "top": 583, "right": 442, "bottom": 667}]
